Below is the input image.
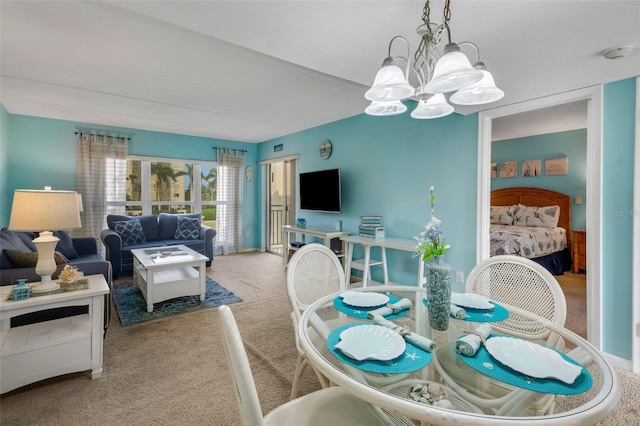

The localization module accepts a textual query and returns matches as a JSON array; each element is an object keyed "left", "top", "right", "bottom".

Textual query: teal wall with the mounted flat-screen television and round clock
[{"left": 258, "top": 105, "right": 478, "bottom": 290}]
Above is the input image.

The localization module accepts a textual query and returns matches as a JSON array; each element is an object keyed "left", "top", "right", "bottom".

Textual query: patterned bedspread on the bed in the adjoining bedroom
[{"left": 490, "top": 224, "right": 567, "bottom": 259}]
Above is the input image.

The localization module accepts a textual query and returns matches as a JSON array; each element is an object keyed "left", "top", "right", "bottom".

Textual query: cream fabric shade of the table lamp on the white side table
[{"left": 9, "top": 189, "right": 82, "bottom": 232}]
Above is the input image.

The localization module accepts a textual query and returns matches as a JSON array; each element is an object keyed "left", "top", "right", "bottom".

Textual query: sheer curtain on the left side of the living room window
[{"left": 74, "top": 133, "right": 128, "bottom": 241}]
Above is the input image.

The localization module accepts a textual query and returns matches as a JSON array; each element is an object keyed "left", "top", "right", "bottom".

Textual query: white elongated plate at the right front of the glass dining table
[{"left": 485, "top": 336, "right": 582, "bottom": 384}]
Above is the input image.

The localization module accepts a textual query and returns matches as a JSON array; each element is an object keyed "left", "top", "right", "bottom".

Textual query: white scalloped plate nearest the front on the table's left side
[{"left": 336, "top": 324, "right": 406, "bottom": 361}]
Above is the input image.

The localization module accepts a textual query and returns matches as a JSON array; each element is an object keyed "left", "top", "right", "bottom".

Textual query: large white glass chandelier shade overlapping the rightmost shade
[{"left": 425, "top": 51, "right": 482, "bottom": 94}]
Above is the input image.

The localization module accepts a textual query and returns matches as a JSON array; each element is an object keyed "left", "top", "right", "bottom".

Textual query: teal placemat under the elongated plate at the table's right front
[{"left": 454, "top": 334, "right": 593, "bottom": 395}]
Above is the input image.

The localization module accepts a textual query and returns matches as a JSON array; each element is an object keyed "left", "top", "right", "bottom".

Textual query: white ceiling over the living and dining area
[{"left": 0, "top": 0, "right": 640, "bottom": 142}]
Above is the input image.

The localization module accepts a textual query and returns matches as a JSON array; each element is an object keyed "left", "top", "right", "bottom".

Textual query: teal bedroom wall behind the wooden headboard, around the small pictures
[{"left": 491, "top": 129, "right": 589, "bottom": 229}]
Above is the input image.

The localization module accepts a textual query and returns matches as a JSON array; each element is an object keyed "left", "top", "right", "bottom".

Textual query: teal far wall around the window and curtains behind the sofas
[{"left": 0, "top": 114, "right": 260, "bottom": 248}]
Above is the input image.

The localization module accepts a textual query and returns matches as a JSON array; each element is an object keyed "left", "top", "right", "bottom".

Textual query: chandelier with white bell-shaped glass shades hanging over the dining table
[{"left": 364, "top": 0, "right": 504, "bottom": 119}]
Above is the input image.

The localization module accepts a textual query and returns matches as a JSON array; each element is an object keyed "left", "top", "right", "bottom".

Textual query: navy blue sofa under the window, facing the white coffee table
[{"left": 100, "top": 213, "right": 216, "bottom": 278}]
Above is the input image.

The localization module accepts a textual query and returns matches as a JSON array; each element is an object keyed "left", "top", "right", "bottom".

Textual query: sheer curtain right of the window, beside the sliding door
[{"left": 216, "top": 148, "right": 246, "bottom": 253}]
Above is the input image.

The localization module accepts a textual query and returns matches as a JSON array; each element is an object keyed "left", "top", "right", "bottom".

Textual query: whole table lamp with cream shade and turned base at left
[{"left": 9, "top": 186, "right": 81, "bottom": 293}]
